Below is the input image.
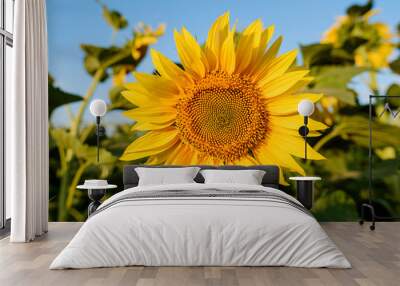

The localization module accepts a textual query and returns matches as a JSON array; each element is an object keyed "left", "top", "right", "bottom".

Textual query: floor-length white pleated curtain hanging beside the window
[{"left": 6, "top": 0, "right": 49, "bottom": 242}]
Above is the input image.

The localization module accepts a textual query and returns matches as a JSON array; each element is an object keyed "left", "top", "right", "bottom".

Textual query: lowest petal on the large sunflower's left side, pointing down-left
[{"left": 120, "top": 127, "right": 179, "bottom": 161}]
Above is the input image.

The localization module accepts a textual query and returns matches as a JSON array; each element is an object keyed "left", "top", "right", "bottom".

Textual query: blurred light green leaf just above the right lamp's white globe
[{"left": 310, "top": 66, "right": 368, "bottom": 105}]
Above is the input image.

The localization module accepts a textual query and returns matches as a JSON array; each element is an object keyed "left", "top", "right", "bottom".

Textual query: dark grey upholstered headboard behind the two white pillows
[{"left": 123, "top": 165, "right": 279, "bottom": 189}]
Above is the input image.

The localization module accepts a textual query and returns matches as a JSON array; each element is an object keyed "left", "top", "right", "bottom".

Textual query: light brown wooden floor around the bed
[{"left": 0, "top": 222, "right": 400, "bottom": 286}]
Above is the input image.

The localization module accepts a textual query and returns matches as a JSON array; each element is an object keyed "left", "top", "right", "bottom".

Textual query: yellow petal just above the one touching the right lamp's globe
[{"left": 261, "top": 71, "right": 308, "bottom": 98}]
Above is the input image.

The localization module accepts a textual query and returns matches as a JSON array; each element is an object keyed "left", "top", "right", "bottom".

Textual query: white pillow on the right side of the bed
[{"left": 200, "top": 169, "right": 265, "bottom": 185}]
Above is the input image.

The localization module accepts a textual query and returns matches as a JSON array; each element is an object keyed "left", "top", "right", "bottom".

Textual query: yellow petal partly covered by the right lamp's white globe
[{"left": 265, "top": 93, "right": 322, "bottom": 115}]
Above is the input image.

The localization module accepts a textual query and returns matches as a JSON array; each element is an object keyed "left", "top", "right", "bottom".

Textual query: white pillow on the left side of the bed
[{"left": 135, "top": 167, "right": 200, "bottom": 186}]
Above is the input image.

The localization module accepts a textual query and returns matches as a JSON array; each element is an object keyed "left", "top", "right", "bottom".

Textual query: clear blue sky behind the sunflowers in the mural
[{"left": 47, "top": 0, "right": 400, "bottom": 127}]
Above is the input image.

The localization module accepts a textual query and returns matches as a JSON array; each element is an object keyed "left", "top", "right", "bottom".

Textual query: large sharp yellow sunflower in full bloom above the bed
[{"left": 121, "top": 13, "right": 326, "bottom": 182}]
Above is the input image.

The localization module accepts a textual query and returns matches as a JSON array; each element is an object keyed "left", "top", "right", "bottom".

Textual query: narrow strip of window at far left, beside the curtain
[{"left": 0, "top": 0, "right": 14, "bottom": 230}]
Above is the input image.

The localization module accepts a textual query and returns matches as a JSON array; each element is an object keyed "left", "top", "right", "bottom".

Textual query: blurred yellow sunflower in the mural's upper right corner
[{"left": 321, "top": 10, "right": 394, "bottom": 68}]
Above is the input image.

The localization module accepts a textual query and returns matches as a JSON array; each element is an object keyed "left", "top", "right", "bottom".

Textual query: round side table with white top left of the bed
[{"left": 76, "top": 180, "right": 117, "bottom": 216}]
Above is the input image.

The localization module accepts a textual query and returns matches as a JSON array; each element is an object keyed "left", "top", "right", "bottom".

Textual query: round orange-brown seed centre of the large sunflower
[{"left": 176, "top": 72, "right": 268, "bottom": 163}]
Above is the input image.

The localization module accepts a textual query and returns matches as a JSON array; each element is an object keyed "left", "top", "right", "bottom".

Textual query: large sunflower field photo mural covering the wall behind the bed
[{"left": 47, "top": 0, "right": 400, "bottom": 221}]
